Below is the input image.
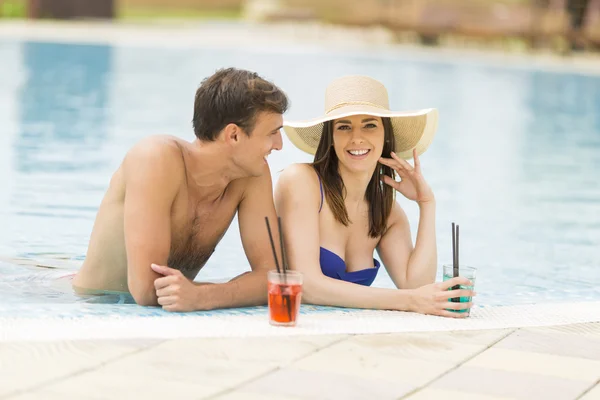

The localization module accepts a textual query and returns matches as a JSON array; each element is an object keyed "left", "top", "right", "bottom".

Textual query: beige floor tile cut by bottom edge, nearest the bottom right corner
[{"left": 429, "top": 366, "right": 589, "bottom": 400}]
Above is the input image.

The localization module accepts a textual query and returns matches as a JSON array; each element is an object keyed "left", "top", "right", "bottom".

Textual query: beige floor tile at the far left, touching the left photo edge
[{"left": 0, "top": 341, "right": 155, "bottom": 396}]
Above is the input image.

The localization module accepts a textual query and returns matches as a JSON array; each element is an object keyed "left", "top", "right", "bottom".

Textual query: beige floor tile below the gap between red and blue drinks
[{"left": 292, "top": 341, "right": 455, "bottom": 386}]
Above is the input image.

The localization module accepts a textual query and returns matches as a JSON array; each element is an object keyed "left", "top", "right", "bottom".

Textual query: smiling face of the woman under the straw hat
[{"left": 333, "top": 115, "right": 385, "bottom": 173}]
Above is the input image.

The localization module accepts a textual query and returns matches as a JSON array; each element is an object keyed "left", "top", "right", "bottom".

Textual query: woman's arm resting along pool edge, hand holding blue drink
[{"left": 275, "top": 164, "right": 466, "bottom": 317}]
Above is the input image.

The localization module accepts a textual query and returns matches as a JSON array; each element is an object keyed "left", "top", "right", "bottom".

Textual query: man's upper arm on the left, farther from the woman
[{"left": 123, "top": 138, "right": 183, "bottom": 306}]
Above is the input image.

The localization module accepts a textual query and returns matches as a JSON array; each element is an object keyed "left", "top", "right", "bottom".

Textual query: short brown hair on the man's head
[{"left": 193, "top": 68, "right": 288, "bottom": 141}]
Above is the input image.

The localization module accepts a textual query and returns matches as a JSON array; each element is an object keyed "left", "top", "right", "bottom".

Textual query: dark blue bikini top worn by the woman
[{"left": 317, "top": 170, "right": 380, "bottom": 286}]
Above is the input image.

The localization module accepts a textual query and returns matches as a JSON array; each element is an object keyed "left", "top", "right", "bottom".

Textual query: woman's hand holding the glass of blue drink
[{"left": 411, "top": 277, "right": 474, "bottom": 318}]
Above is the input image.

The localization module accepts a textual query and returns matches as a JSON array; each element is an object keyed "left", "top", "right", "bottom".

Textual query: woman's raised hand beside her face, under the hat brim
[{"left": 379, "top": 149, "right": 435, "bottom": 203}]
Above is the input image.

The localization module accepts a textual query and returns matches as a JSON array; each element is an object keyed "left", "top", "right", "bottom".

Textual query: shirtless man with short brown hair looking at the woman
[{"left": 73, "top": 68, "right": 288, "bottom": 311}]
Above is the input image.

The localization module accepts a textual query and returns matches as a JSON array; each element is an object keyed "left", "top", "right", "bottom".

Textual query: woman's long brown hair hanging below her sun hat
[{"left": 312, "top": 117, "right": 396, "bottom": 238}]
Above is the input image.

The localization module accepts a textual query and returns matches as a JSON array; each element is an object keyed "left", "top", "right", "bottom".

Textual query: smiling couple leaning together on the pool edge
[{"left": 73, "top": 68, "right": 472, "bottom": 318}]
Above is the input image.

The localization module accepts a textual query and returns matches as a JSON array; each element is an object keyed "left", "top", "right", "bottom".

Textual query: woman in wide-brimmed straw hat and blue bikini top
[{"left": 275, "top": 76, "right": 472, "bottom": 318}]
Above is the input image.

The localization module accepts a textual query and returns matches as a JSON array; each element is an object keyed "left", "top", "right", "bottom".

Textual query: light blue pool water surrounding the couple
[{"left": 0, "top": 37, "right": 600, "bottom": 312}]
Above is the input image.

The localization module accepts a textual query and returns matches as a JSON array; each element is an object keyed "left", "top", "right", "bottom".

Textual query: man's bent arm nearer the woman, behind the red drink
[{"left": 198, "top": 166, "right": 281, "bottom": 308}]
